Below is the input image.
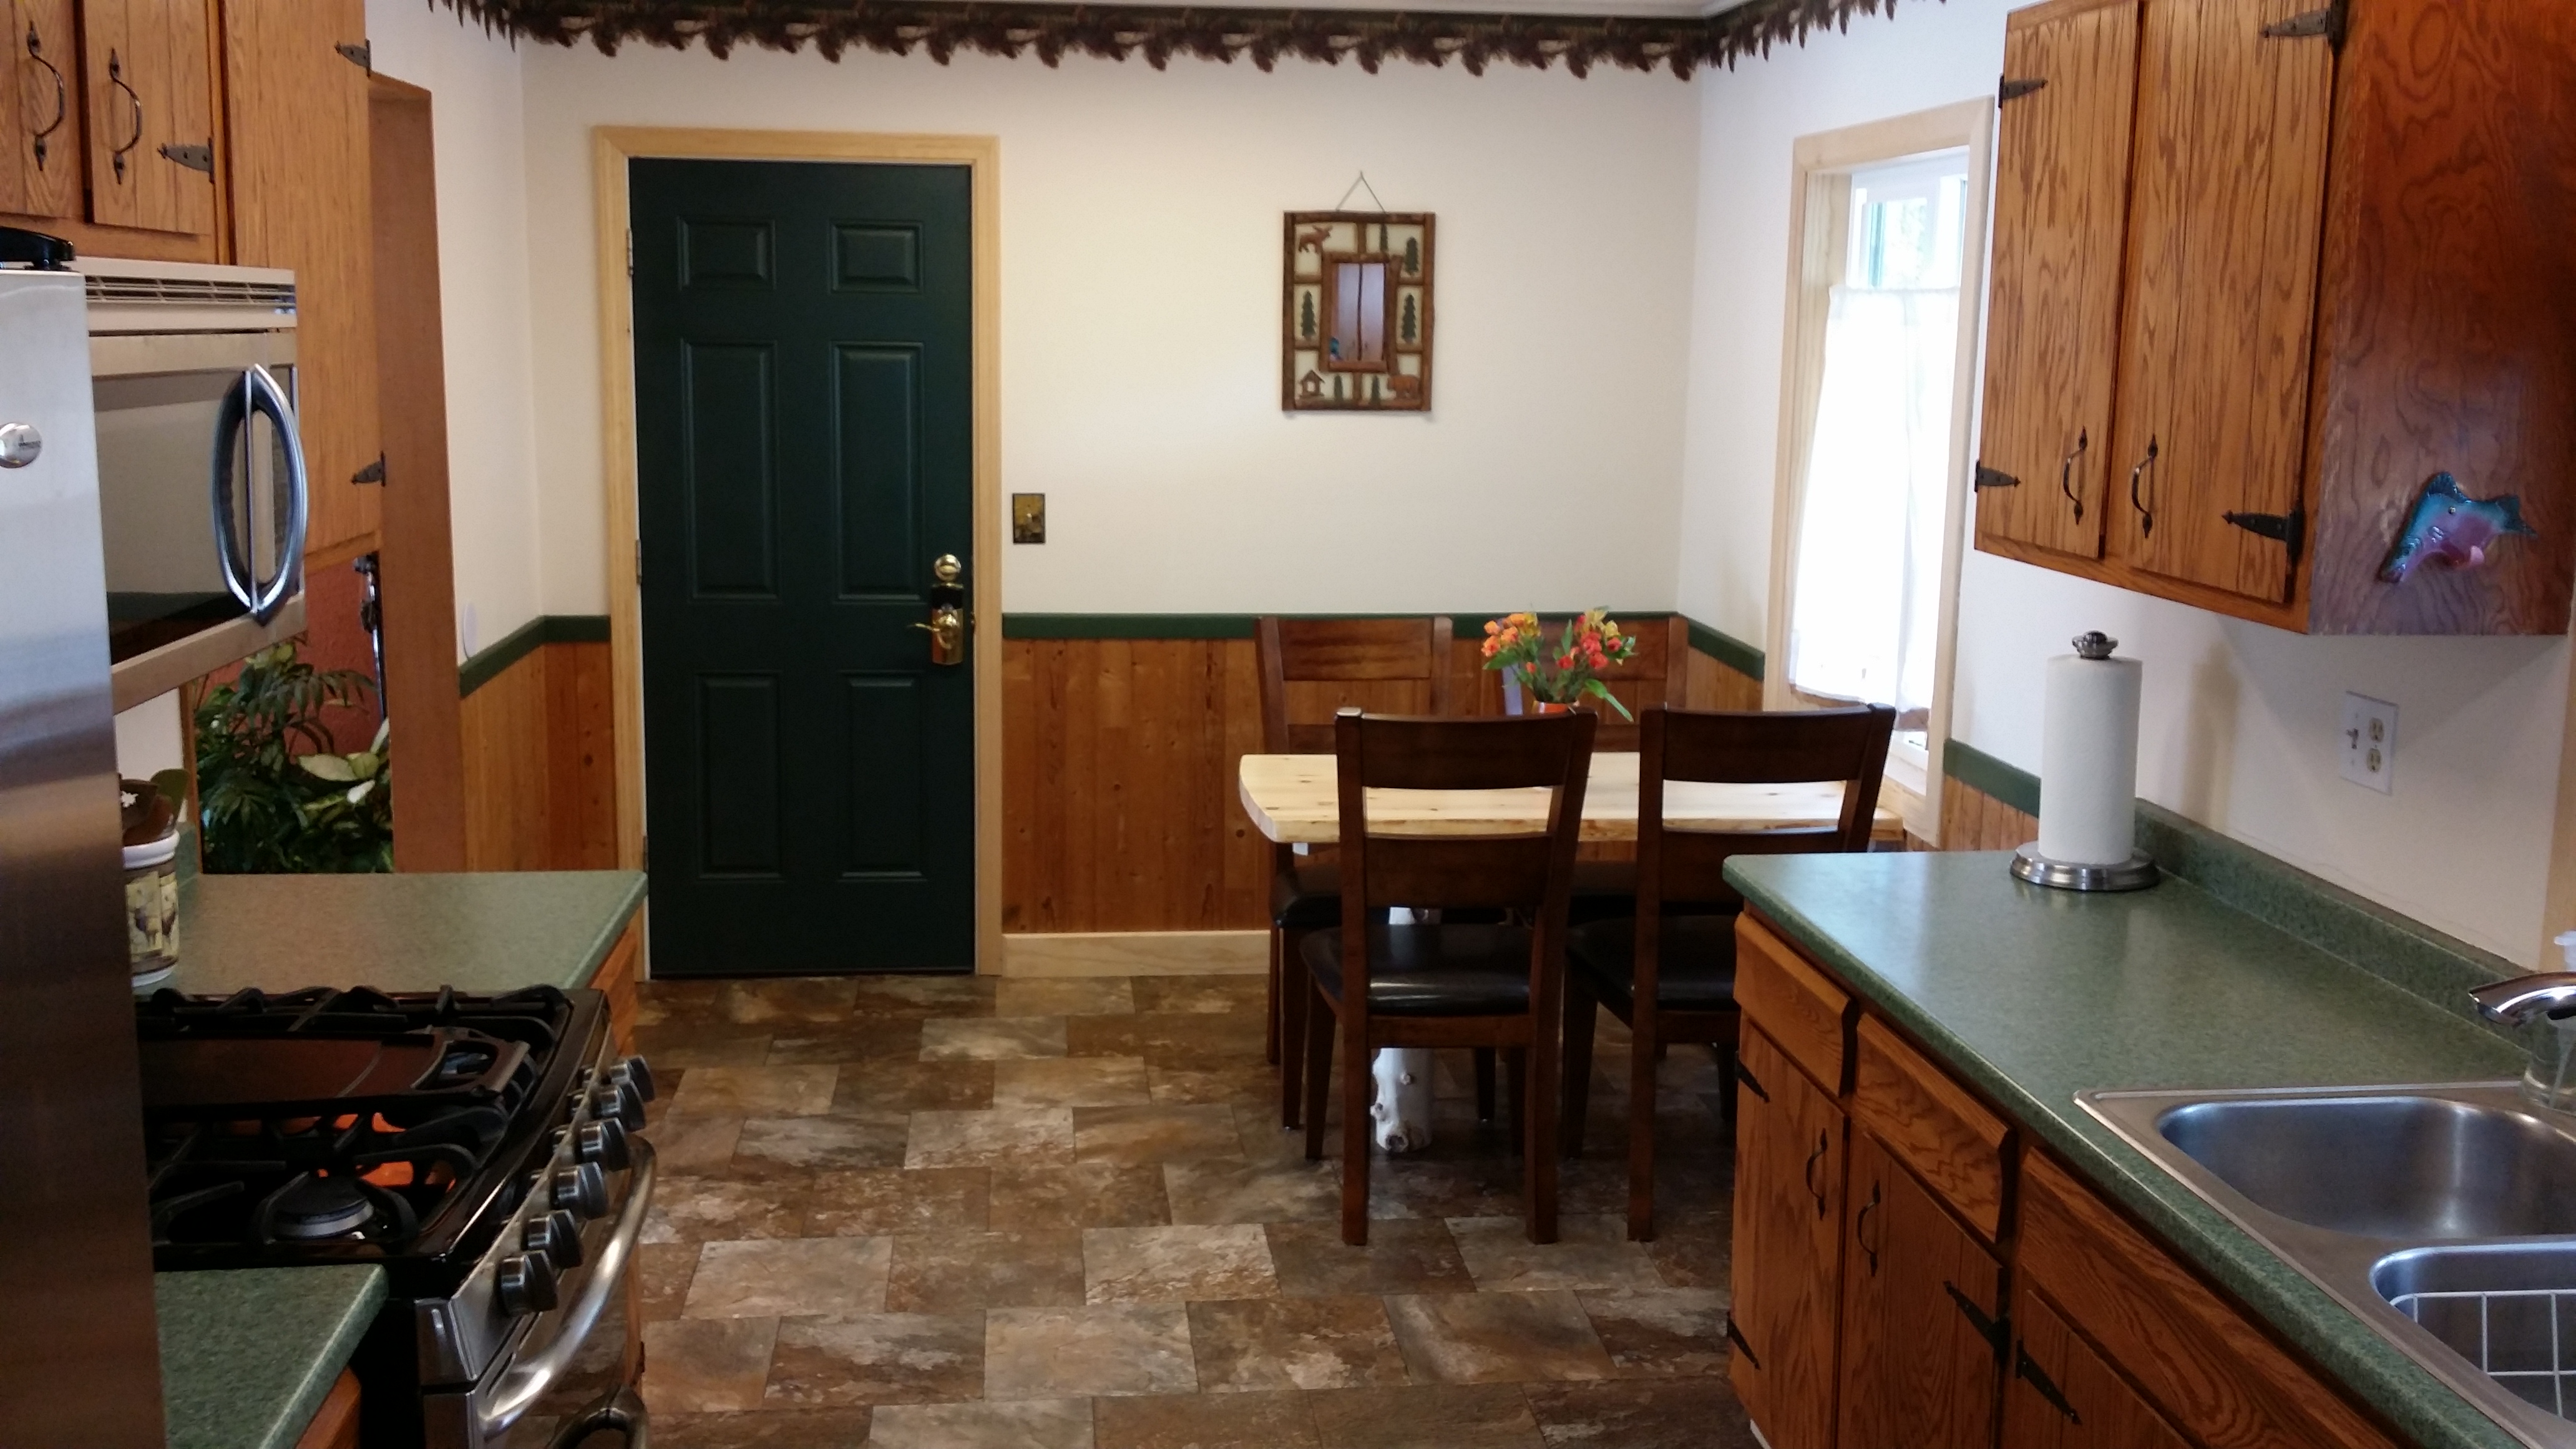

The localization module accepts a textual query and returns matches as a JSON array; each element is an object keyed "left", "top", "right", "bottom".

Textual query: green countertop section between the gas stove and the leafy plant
[{"left": 162, "top": 872, "right": 644, "bottom": 995}]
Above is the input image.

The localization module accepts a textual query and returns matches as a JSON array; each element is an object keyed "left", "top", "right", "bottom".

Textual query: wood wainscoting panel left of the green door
[{"left": 459, "top": 640, "right": 618, "bottom": 872}]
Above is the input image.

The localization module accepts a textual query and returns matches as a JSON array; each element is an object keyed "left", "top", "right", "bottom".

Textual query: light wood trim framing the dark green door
[{"left": 590, "top": 126, "right": 1005, "bottom": 972}]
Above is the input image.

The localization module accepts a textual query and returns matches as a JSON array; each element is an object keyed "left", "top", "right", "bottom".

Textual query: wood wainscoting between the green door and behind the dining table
[{"left": 994, "top": 634, "right": 1762, "bottom": 934}]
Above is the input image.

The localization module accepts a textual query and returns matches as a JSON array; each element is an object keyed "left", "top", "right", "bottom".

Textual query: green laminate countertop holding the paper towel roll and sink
[{"left": 1726, "top": 854, "right": 2522, "bottom": 1449}]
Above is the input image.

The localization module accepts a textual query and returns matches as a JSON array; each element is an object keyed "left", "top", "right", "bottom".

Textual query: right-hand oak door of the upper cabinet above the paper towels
[{"left": 2110, "top": 0, "right": 2334, "bottom": 603}]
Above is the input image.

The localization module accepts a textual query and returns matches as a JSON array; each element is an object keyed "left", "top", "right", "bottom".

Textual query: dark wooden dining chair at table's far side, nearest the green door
[{"left": 1254, "top": 616, "right": 1450, "bottom": 1127}]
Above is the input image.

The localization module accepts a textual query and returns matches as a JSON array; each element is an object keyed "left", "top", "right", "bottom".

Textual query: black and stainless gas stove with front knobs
[{"left": 137, "top": 987, "right": 655, "bottom": 1449}]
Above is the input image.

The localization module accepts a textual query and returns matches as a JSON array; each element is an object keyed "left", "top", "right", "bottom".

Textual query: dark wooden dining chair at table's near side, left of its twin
[{"left": 1301, "top": 709, "right": 1599, "bottom": 1246}]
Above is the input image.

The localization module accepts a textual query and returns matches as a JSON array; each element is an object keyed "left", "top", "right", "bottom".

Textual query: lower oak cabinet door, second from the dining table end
[{"left": 1837, "top": 1132, "right": 2004, "bottom": 1449}]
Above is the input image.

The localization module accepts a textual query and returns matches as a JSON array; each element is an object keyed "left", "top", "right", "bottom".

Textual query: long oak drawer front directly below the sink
[{"left": 2017, "top": 1153, "right": 2396, "bottom": 1449}]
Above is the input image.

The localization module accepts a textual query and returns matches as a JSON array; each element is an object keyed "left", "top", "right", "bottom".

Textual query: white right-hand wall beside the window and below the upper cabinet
[{"left": 1677, "top": 0, "right": 2569, "bottom": 962}]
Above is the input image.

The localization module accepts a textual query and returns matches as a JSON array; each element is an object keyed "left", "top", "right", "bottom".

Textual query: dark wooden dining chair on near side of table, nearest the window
[{"left": 1564, "top": 704, "right": 1896, "bottom": 1242}]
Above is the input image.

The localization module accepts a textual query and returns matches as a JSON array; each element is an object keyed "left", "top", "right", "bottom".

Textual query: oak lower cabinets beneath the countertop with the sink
[{"left": 1729, "top": 910, "right": 2398, "bottom": 1449}]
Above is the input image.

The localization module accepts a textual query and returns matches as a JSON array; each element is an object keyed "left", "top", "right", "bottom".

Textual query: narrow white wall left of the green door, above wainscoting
[{"left": 366, "top": 0, "right": 540, "bottom": 652}]
